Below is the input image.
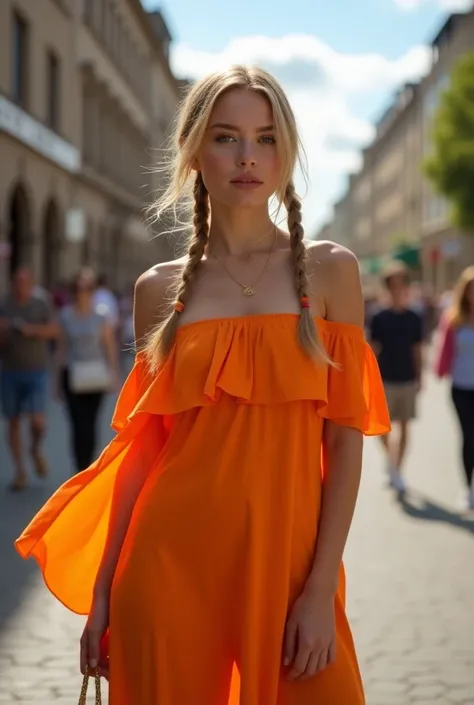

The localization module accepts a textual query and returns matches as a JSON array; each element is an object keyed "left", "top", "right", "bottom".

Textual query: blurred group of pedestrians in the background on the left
[{"left": 0, "top": 267, "right": 133, "bottom": 492}]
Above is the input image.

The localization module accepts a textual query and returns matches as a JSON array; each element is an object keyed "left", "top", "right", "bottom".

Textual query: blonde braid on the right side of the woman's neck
[{"left": 284, "top": 181, "right": 330, "bottom": 362}]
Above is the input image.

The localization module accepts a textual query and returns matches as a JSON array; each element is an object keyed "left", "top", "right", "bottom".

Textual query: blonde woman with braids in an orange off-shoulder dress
[{"left": 16, "top": 67, "right": 389, "bottom": 705}]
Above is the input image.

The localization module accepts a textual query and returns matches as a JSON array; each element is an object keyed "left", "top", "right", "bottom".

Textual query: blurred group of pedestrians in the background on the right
[{"left": 366, "top": 264, "right": 474, "bottom": 511}]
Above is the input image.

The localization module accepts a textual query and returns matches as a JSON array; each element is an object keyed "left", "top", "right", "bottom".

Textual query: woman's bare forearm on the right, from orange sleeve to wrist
[{"left": 308, "top": 424, "right": 363, "bottom": 594}]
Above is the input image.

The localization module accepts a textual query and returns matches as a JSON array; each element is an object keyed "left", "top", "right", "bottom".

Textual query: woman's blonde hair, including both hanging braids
[{"left": 145, "top": 66, "right": 329, "bottom": 368}]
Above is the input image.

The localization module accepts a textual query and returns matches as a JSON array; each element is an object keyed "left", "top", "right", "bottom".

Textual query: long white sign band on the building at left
[{"left": 0, "top": 95, "right": 81, "bottom": 173}]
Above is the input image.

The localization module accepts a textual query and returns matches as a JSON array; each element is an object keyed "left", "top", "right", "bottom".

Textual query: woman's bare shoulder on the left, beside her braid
[{"left": 133, "top": 257, "right": 186, "bottom": 341}]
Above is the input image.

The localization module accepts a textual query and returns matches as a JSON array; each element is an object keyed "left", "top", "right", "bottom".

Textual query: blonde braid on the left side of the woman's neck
[{"left": 146, "top": 172, "right": 209, "bottom": 370}]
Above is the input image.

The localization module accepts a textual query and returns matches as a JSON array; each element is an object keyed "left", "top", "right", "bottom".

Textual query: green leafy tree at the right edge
[{"left": 424, "top": 52, "right": 474, "bottom": 232}]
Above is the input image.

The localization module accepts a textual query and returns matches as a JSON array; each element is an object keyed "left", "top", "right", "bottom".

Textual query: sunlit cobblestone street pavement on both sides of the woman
[{"left": 0, "top": 372, "right": 474, "bottom": 705}]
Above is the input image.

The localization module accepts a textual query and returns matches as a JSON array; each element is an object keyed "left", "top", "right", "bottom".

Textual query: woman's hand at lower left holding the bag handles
[{"left": 80, "top": 594, "right": 110, "bottom": 680}]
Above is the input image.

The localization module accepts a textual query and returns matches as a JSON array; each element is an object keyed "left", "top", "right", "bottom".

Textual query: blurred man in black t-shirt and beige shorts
[{"left": 370, "top": 265, "right": 423, "bottom": 492}]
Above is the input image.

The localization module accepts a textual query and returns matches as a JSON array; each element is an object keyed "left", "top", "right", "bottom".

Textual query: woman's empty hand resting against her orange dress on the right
[{"left": 283, "top": 588, "right": 336, "bottom": 681}]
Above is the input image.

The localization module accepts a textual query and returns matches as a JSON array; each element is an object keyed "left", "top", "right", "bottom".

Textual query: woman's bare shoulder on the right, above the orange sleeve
[{"left": 307, "top": 240, "right": 364, "bottom": 326}]
